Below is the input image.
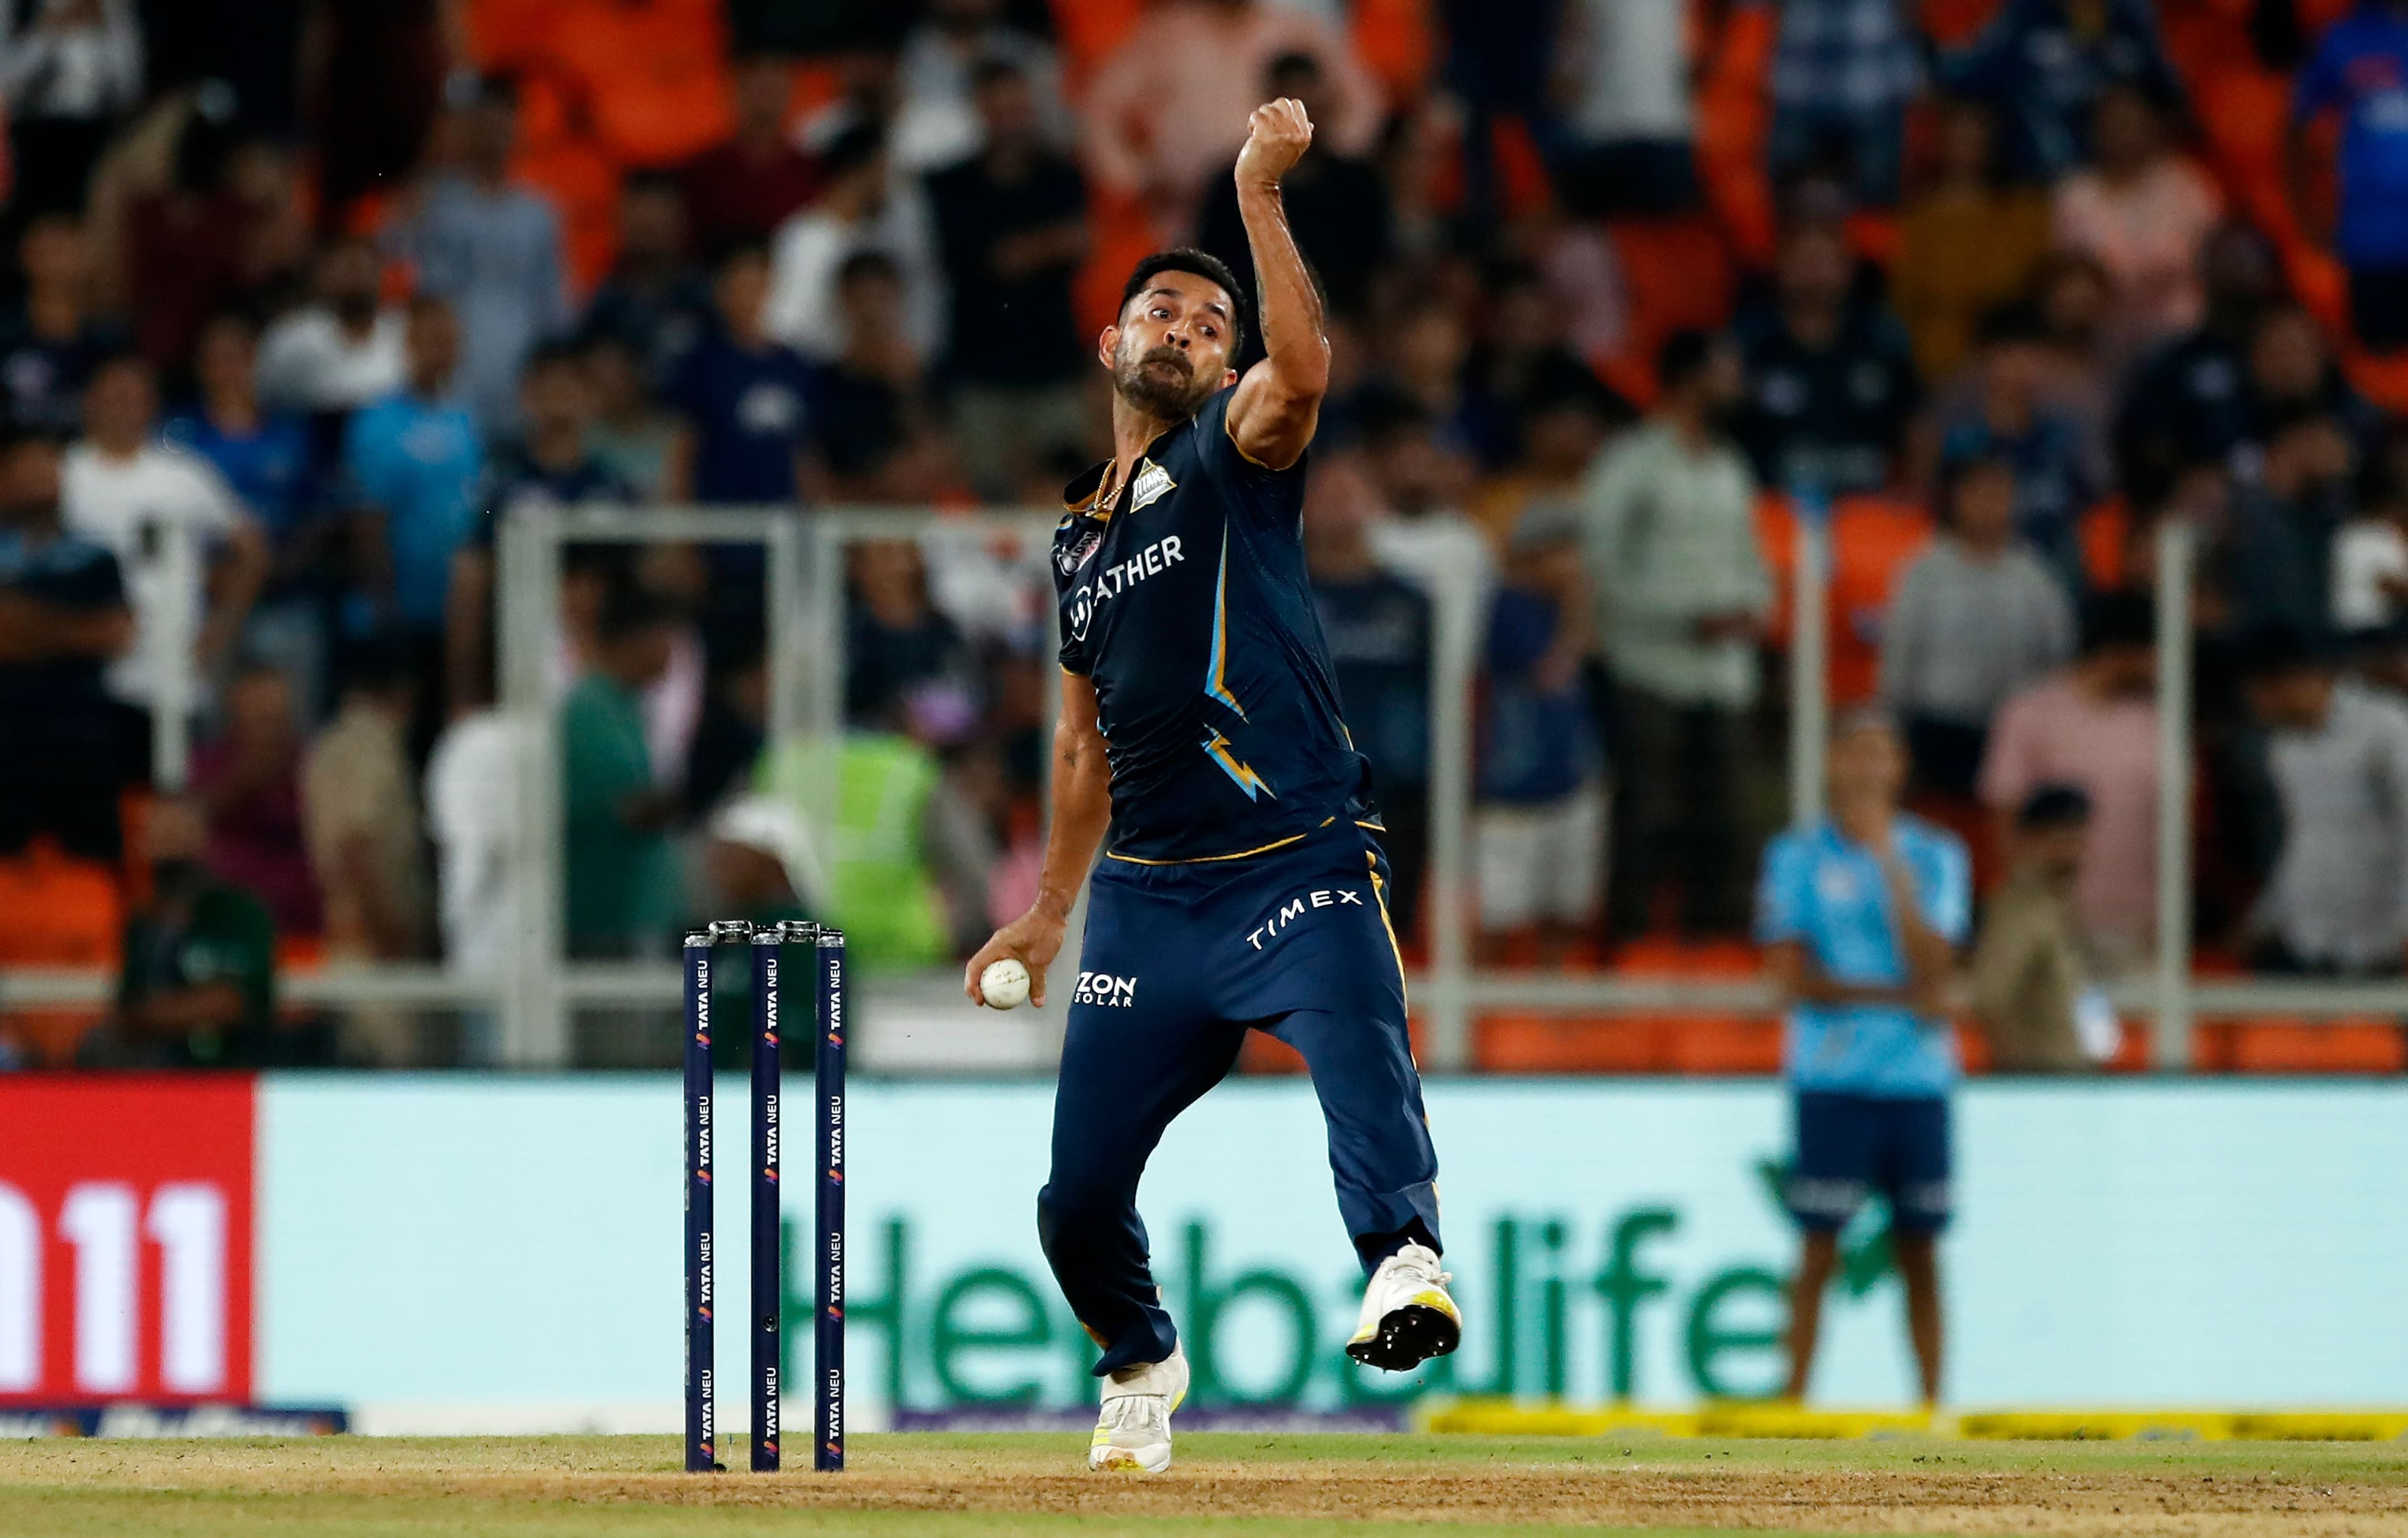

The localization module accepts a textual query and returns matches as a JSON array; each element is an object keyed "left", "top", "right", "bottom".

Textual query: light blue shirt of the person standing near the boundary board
[{"left": 1755, "top": 816, "right": 1972, "bottom": 1100}]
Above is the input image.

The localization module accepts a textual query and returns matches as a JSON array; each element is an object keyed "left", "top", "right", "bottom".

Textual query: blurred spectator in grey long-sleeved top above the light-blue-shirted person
[{"left": 1881, "top": 457, "right": 2073, "bottom": 797}]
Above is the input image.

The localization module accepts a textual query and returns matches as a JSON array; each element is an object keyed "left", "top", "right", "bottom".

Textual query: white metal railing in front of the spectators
[{"left": 0, "top": 501, "right": 2408, "bottom": 1071}]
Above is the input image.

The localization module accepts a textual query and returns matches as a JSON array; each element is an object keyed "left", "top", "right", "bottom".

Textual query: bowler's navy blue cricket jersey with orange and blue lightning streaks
[{"left": 1055, "top": 390, "right": 1373, "bottom": 864}]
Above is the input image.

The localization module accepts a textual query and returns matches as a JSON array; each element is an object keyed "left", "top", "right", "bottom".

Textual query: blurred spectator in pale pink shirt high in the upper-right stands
[{"left": 2056, "top": 84, "right": 2225, "bottom": 354}]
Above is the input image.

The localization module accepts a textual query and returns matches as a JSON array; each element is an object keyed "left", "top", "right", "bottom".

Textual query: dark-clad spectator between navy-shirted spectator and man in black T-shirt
[{"left": 816, "top": 250, "right": 937, "bottom": 503}]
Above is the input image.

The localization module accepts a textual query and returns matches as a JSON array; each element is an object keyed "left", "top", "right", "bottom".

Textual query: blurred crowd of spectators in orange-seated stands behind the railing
[{"left": 0, "top": 0, "right": 2408, "bottom": 1064}]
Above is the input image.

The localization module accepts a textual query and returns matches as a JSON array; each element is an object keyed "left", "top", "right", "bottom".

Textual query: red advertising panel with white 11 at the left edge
[{"left": 0, "top": 1078, "right": 253, "bottom": 1406}]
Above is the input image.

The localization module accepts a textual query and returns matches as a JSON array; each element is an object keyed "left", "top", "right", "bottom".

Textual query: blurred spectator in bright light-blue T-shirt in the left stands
[{"left": 342, "top": 296, "right": 484, "bottom": 713}]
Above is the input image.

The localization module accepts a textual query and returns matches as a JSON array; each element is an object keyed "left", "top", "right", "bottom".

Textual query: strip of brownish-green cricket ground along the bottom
[{"left": 0, "top": 1432, "right": 2408, "bottom": 1538}]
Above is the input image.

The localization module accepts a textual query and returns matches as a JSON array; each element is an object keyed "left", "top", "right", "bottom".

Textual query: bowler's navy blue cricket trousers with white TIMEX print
[{"left": 1038, "top": 819, "right": 1437, "bottom": 1377}]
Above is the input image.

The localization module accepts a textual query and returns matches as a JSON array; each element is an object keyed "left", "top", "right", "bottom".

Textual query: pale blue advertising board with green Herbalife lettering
[{"left": 255, "top": 1076, "right": 2408, "bottom": 1429}]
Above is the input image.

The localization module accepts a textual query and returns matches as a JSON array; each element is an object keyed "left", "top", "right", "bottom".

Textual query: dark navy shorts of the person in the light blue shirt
[{"left": 1787, "top": 1090, "right": 1950, "bottom": 1235}]
